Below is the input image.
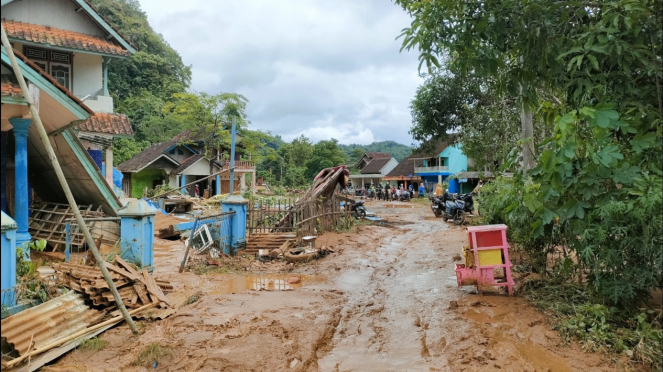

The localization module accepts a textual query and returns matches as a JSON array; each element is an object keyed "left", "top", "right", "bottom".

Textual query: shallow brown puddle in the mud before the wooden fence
[{"left": 208, "top": 274, "right": 324, "bottom": 295}]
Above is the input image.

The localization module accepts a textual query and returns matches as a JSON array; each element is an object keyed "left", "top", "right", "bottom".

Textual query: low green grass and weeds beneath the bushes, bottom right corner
[{"left": 521, "top": 278, "right": 663, "bottom": 371}]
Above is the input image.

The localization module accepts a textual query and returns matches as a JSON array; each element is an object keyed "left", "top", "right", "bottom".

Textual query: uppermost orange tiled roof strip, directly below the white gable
[{"left": 2, "top": 19, "right": 131, "bottom": 57}]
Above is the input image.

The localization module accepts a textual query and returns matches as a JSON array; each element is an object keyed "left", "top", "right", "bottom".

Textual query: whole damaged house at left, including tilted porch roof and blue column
[{"left": 0, "top": 0, "right": 136, "bottom": 303}]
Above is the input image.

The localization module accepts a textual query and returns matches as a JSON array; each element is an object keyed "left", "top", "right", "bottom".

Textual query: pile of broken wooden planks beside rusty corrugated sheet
[{"left": 53, "top": 256, "right": 173, "bottom": 309}]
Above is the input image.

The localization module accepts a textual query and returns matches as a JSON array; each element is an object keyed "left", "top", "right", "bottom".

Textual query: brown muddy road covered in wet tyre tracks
[{"left": 53, "top": 202, "right": 619, "bottom": 372}]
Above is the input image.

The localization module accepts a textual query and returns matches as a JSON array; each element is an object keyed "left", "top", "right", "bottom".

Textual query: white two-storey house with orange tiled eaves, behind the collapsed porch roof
[{"left": 2, "top": 0, "right": 136, "bottom": 187}]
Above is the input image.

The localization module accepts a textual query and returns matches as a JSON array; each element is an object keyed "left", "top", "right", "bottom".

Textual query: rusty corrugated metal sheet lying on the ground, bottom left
[{"left": 1, "top": 291, "right": 104, "bottom": 355}]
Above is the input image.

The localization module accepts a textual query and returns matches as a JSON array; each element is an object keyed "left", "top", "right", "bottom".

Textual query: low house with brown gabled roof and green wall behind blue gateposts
[{"left": 117, "top": 130, "right": 256, "bottom": 198}]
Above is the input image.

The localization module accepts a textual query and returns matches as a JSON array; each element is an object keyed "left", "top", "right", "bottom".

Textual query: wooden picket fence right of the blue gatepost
[{"left": 246, "top": 195, "right": 346, "bottom": 236}]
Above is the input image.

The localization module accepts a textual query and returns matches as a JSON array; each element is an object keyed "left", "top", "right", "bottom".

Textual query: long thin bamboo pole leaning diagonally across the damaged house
[{"left": 0, "top": 26, "right": 138, "bottom": 334}]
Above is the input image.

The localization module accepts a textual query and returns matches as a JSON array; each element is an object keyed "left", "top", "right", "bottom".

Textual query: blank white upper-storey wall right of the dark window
[{"left": 73, "top": 53, "right": 102, "bottom": 99}]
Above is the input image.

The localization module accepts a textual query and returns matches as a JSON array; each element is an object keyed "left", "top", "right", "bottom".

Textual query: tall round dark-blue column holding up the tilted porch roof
[{"left": 9, "top": 118, "right": 32, "bottom": 253}]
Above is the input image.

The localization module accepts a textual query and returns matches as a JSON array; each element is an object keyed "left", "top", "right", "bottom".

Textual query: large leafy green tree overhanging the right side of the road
[{"left": 397, "top": 0, "right": 663, "bottom": 307}]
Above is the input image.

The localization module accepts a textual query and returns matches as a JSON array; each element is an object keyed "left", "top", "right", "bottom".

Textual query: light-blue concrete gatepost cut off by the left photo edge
[{"left": 0, "top": 212, "right": 17, "bottom": 307}]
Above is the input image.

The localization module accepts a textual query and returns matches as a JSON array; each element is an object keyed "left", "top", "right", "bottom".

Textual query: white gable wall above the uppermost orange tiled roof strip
[{"left": 2, "top": 0, "right": 106, "bottom": 37}]
